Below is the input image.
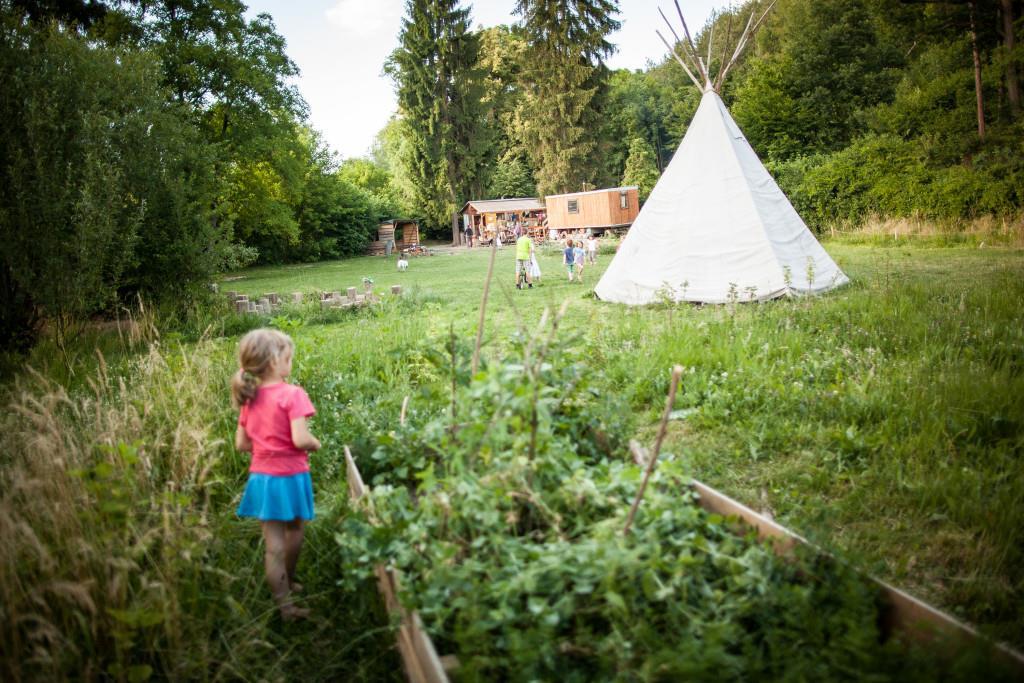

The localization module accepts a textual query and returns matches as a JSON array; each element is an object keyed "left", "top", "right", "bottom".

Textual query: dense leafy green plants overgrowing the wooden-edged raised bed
[{"left": 338, "top": 318, "right": 1009, "bottom": 681}]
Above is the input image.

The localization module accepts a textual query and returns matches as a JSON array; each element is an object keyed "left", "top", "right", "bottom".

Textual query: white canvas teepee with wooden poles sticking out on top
[{"left": 595, "top": 0, "right": 849, "bottom": 304}]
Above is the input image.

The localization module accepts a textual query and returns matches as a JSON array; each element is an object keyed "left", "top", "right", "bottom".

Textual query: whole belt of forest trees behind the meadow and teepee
[{"left": 0, "top": 0, "right": 1024, "bottom": 351}]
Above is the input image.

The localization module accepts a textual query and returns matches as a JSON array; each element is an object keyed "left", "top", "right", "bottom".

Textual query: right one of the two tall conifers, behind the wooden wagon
[{"left": 515, "top": 0, "right": 620, "bottom": 195}]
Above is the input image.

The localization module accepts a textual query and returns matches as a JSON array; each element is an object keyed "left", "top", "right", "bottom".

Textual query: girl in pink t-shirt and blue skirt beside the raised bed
[{"left": 231, "top": 330, "right": 321, "bottom": 620}]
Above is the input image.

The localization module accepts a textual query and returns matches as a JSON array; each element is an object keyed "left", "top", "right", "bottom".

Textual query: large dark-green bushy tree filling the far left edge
[{"left": 0, "top": 17, "right": 228, "bottom": 347}]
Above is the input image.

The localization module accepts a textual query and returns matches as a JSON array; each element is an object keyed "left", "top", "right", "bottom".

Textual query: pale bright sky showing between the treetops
[{"left": 248, "top": 0, "right": 727, "bottom": 159}]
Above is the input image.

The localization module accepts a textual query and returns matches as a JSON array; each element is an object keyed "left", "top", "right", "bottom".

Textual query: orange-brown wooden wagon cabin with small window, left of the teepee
[{"left": 544, "top": 185, "right": 640, "bottom": 236}]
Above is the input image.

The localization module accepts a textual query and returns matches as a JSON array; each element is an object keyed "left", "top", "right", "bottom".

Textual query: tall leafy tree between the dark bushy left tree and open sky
[{"left": 115, "top": 0, "right": 306, "bottom": 260}]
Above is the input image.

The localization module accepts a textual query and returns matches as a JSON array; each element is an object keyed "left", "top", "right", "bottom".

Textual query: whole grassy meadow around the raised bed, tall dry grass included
[{"left": 0, "top": 233, "right": 1024, "bottom": 680}]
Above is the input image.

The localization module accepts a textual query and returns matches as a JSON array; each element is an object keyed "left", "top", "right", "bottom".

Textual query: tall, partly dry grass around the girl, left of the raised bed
[{"left": 0, "top": 341, "right": 396, "bottom": 681}]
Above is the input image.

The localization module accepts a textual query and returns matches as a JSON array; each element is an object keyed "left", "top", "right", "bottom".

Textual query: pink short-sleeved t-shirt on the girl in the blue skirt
[{"left": 239, "top": 382, "right": 316, "bottom": 476}]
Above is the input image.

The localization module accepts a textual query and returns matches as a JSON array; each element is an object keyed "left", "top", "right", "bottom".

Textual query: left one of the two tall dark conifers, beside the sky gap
[{"left": 387, "top": 0, "right": 484, "bottom": 234}]
